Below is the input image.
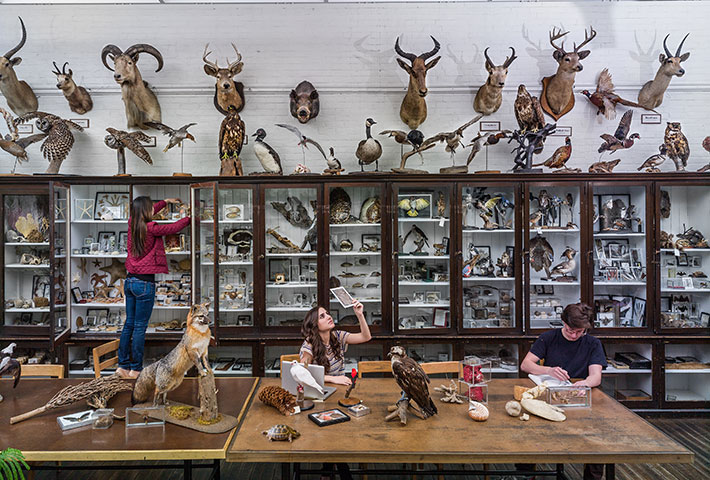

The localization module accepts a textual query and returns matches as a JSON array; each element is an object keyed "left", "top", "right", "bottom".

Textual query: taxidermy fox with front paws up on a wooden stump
[{"left": 131, "top": 303, "right": 211, "bottom": 405}]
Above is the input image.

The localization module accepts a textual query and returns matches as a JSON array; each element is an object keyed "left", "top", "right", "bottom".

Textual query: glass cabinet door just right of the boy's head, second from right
[{"left": 590, "top": 184, "right": 648, "bottom": 328}]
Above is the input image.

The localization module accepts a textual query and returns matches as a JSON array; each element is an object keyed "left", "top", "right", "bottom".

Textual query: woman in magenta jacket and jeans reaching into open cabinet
[{"left": 116, "top": 197, "right": 190, "bottom": 378}]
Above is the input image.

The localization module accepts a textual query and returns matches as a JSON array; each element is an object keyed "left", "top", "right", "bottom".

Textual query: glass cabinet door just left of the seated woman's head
[{"left": 264, "top": 187, "right": 318, "bottom": 327}]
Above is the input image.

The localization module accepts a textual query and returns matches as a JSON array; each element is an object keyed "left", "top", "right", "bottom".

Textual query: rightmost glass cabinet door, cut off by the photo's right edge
[{"left": 656, "top": 185, "right": 710, "bottom": 329}]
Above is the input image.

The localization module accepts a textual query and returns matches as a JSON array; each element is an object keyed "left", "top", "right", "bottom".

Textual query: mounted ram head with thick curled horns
[{"left": 101, "top": 43, "right": 163, "bottom": 129}]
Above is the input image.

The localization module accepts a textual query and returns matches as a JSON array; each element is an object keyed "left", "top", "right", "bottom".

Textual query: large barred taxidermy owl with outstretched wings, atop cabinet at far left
[{"left": 15, "top": 112, "right": 84, "bottom": 173}]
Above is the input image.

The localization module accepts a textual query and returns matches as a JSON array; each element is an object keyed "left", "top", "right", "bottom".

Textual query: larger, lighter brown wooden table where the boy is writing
[{"left": 227, "top": 378, "right": 693, "bottom": 479}]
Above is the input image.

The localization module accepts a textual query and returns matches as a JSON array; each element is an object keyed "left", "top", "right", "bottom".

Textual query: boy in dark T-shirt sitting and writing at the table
[{"left": 518, "top": 303, "right": 607, "bottom": 480}]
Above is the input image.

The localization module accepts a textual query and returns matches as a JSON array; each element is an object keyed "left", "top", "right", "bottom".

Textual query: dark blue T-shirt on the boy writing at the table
[{"left": 530, "top": 328, "right": 607, "bottom": 378}]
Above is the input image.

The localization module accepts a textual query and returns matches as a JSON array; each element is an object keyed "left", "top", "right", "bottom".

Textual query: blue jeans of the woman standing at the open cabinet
[{"left": 118, "top": 277, "right": 155, "bottom": 372}]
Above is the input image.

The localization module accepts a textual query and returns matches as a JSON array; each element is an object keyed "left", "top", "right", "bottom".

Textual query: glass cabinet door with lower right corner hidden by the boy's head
[{"left": 525, "top": 184, "right": 581, "bottom": 329}]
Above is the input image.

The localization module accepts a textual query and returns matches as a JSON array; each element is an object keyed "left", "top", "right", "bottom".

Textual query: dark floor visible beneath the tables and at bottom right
[{"left": 30, "top": 418, "right": 710, "bottom": 480}]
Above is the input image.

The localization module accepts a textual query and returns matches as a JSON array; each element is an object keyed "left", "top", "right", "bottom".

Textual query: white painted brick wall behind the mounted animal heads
[{"left": 0, "top": 1, "right": 710, "bottom": 175}]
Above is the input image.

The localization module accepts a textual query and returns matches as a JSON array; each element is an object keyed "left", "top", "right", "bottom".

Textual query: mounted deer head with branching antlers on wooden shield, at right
[{"left": 540, "top": 27, "right": 597, "bottom": 120}]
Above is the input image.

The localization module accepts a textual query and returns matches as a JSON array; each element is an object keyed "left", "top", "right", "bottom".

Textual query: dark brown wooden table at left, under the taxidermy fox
[{"left": 0, "top": 377, "right": 258, "bottom": 478}]
